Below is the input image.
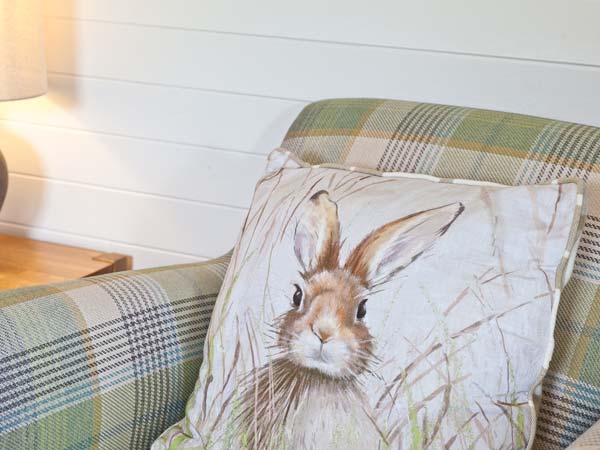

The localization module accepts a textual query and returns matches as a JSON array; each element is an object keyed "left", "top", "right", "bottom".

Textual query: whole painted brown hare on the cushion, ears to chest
[{"left": 240, "top": 191, "right": 464, "bottom": 450}]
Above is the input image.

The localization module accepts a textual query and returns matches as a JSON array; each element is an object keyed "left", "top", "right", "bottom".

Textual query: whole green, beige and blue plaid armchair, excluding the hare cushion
[{"left": 0, "top": 99, "right": 600, "bottom": 450}]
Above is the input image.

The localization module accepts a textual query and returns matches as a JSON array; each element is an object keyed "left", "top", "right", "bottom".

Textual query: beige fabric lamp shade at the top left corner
[{"left": 0, "top": 0, "right": 48, "bottom": 101}]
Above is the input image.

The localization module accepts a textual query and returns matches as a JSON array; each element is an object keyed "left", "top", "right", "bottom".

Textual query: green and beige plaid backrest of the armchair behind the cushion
[{"left": 282, "top": 99, "right": 600, "bottom": 450}]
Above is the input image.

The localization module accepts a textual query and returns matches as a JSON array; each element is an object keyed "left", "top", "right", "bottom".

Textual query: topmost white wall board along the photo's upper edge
[{"left": 47, "top": 0, "right": 600, "bottom": 65}]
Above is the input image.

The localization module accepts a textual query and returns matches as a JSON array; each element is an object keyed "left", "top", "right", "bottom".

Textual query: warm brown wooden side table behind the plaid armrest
[{"left": 0, "top": 233, "right": 132, "bottom": 290}]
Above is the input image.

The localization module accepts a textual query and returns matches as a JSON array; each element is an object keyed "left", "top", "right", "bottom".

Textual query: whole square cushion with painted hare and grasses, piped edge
[{"left": 153, "top": 150, "right": 583, "bottom": 450}]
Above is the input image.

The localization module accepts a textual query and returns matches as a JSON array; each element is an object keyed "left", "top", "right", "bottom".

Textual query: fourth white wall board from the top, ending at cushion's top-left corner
[{"left": 0, "top": 122, "right": 265, "bottom": 208}]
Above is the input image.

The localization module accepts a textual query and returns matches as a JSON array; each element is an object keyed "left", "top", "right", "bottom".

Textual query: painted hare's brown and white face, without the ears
[{"left": 278, "top": 269, "right": 373, "bottom": 378}]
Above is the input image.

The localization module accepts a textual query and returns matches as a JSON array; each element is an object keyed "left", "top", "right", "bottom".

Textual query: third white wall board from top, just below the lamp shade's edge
[{"left": 0, "top": 75, "right": 304, "bottom": 154}]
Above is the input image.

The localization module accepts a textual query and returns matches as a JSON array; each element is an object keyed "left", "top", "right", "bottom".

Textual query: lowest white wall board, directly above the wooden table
[{"left": 0, "top": 222, "right": 206, "bottom": 269}]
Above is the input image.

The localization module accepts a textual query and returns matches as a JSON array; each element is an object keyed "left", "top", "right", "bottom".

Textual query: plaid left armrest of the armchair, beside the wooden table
[{"left": 0, "top": 257, "right": 229, "bottom": 450}]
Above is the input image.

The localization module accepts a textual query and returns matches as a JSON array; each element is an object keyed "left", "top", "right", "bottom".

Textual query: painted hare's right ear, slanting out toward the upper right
[{"left": 346, "top": 203, "right": 464, "bottom": 287}]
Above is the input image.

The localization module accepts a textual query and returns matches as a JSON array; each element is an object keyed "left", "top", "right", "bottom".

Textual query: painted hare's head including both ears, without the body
[{"left": 277, "top": 191, "right": 464, "bottom": 379}]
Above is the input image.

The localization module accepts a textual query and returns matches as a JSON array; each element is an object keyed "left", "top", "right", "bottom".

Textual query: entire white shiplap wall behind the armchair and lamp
[{"left": 0, "top": 0, "right": 600, "bottom": 267}]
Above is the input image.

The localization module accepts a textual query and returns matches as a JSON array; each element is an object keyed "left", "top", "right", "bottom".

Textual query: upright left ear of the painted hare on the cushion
[{"left": 294, "top": 191, "right": 340, "bottom": 274}]
